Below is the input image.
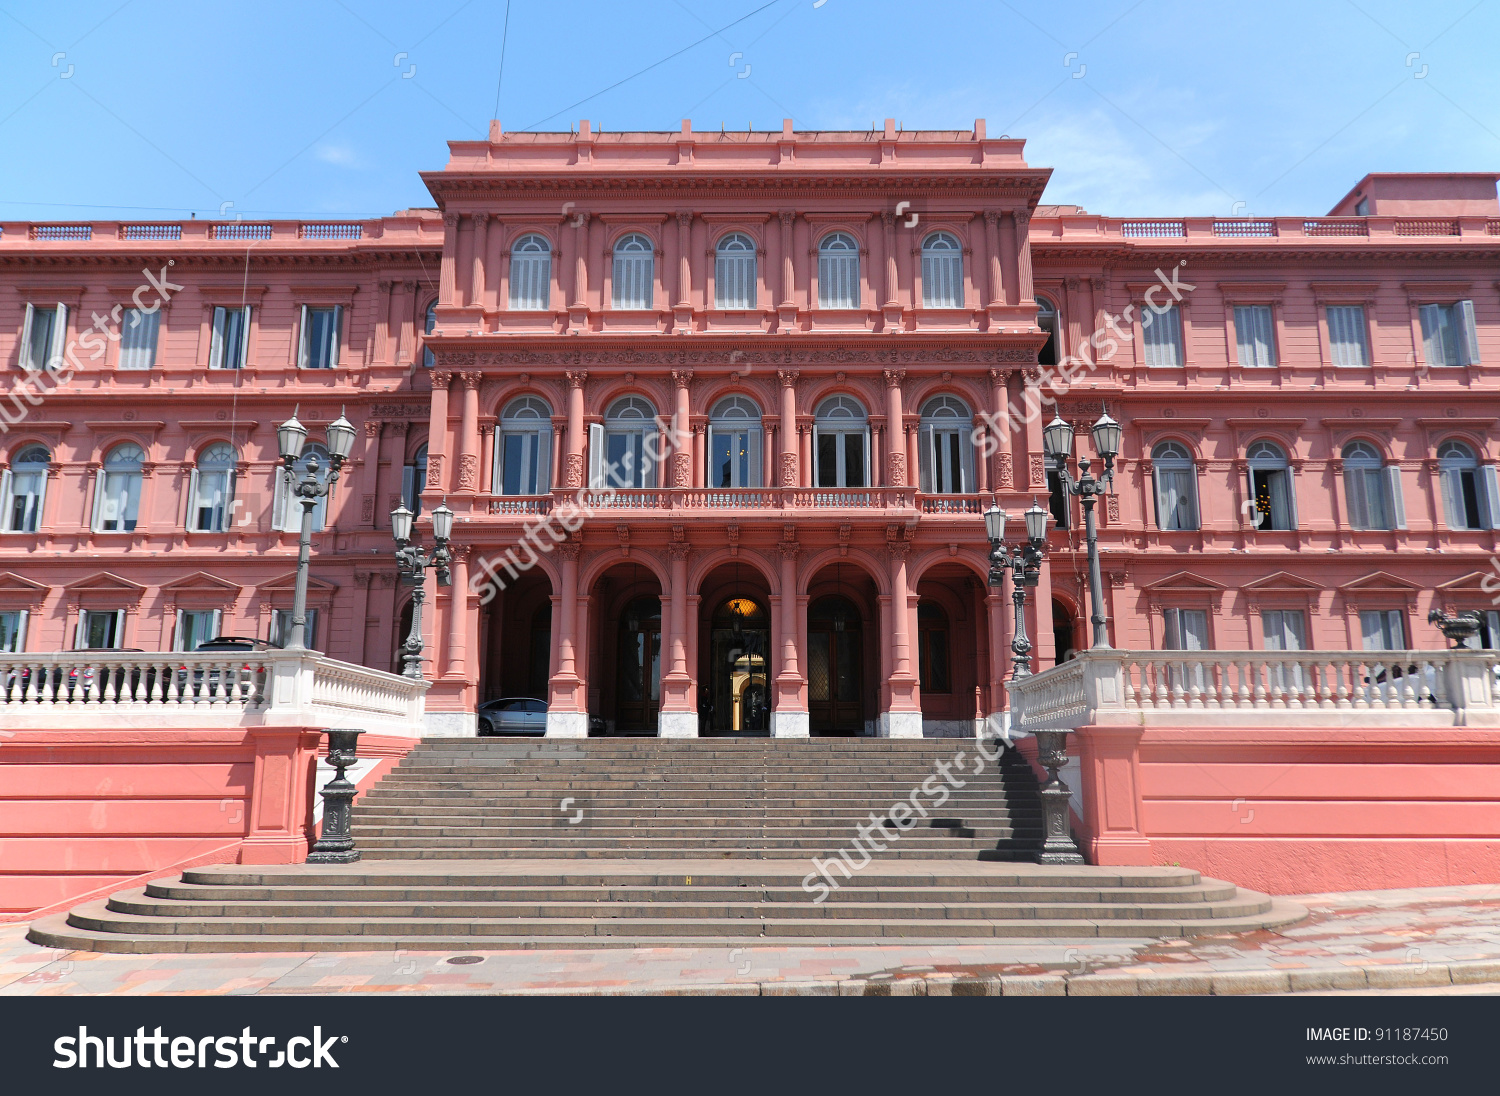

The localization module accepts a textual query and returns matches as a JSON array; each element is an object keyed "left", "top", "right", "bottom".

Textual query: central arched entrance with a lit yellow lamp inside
[{"left": 699, "top": 597, "right": 771, "bottom": 735}]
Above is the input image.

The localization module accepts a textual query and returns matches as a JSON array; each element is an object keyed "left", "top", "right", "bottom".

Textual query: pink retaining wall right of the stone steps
[{"left": 1070, "top": 727, "right": 1500, "bottom": 894}]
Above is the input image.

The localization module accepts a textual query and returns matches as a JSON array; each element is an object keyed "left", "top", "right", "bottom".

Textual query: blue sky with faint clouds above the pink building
[{"left": 0, "top": 0, "right": 1500, "bottom": 220}]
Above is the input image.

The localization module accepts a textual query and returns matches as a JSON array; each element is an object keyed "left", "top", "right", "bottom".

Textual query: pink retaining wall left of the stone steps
[{"left": 0, "top": 727, "right": 414, "bottom": 913}]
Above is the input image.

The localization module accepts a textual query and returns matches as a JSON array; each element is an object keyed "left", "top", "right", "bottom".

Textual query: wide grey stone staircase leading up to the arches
[{"left": 30, "top": 739, "right": 1305, "bottom": 952}]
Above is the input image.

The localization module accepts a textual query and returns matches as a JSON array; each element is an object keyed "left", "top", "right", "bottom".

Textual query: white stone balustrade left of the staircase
[{"left": 0, "top": 651, "right": 428, "bottom": 736}]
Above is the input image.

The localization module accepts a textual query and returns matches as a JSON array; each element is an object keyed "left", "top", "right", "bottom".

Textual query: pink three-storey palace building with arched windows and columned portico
[{"left": 0, "top": 121, "right": 1500, "bottom": 736}]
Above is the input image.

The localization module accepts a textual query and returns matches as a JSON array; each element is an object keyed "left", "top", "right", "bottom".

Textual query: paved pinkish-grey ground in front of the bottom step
[{"left": 0, "top": 885, "right": 1500, "bottom": 997}]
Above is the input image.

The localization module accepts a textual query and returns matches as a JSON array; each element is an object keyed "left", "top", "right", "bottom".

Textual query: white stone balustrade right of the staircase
[{"left": 1010, "top": 649, "right": 1500, "bottom": 732}]
